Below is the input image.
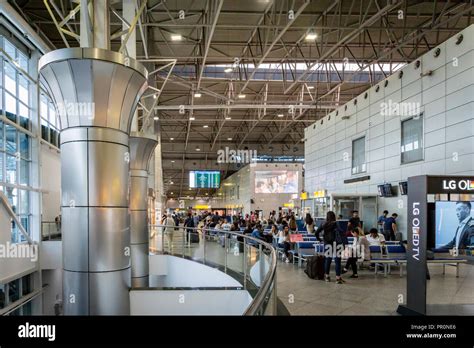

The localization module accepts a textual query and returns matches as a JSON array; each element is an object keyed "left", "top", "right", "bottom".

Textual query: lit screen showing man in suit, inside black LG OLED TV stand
[{"left": 435, "top": 201, "right": 474, "bottom": 250}]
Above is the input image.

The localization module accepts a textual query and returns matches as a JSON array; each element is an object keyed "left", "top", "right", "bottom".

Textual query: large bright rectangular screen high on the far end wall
[{"left": 255, "top": 170, "right": 298, "bottom": 193}]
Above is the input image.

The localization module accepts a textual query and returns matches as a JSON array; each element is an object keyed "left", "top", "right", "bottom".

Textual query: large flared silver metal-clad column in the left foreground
[{"left": 39, "top": 48, "right": 147, "bottom": 315}]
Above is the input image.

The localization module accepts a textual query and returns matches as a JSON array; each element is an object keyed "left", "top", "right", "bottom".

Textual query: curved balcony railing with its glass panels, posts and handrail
[{"left": 150, "top": 225, "right": 277, "bottom": 315}]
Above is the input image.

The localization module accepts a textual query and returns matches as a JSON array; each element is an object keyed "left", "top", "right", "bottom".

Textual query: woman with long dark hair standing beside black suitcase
[{"left": 316, "top": 211, "right": 347, "bottom": 284}]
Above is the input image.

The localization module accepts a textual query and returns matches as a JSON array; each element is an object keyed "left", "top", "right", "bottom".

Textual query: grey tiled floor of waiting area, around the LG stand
[{"left": 277, "top": 262, "right": 474, "bottom": 315}]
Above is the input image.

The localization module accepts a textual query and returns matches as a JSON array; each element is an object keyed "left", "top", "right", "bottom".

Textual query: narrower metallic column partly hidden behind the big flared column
[{"left": 130, "top": 132, "right": 158, "bottom": 288}]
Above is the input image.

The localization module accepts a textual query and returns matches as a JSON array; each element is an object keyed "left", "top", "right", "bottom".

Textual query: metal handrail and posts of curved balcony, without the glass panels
[{"left": 149, "top": 224, "right": 277, "bottom": 315}]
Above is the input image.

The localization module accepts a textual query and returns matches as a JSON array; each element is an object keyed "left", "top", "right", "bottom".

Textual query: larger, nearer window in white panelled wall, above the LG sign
[{"left": 400, "top": 116, "right": 423, "bottom": 164}]
